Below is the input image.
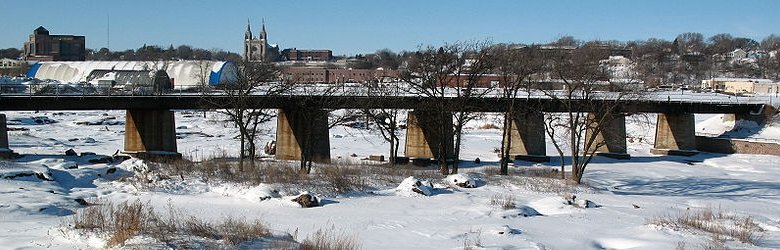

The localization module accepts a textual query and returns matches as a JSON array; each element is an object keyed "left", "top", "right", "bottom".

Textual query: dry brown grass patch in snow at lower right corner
[{"left": 649, "top": 208, "right": 764, "bottom": 245}]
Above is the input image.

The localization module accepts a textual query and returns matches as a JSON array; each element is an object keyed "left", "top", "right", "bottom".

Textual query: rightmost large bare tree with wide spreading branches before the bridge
[{"left": 544, "top": 43, "right": 637, "bottom": 183}]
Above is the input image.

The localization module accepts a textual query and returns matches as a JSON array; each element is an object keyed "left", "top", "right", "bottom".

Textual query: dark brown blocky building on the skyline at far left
[{"left": 24, "top": 26, "right": 87, "bottom": 61}]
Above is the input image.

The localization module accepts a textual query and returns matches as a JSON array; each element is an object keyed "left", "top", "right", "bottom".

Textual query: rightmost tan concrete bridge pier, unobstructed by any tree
[{"left": 651, "top": 113, "right": 698, "bottom": 156}]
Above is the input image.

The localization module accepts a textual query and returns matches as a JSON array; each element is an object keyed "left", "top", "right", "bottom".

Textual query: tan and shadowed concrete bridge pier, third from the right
[{"left": 503, "top": 111, "right": 550, "bottom": 162}]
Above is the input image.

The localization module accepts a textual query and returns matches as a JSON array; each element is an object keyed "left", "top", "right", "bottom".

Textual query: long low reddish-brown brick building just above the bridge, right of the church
[{"left": 282, "top": 67, "right": 399, "bottom": 83}]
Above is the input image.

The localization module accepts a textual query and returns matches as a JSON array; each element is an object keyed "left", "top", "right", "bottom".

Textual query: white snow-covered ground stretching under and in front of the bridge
[{"left": 0, "top": 111, "right": 780, "bottom": 249}]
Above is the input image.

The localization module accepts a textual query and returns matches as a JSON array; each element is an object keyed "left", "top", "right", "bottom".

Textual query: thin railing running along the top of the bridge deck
[{"left": 0, "top": 82, "right": 780, "bottom": 106}]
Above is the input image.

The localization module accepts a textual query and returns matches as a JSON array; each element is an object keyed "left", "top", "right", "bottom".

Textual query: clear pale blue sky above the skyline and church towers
[{"left": 0, "top": 0, "right": 780, "bottom": 55}]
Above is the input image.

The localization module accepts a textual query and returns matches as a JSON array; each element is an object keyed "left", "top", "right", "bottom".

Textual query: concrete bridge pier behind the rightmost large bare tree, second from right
[{"left": 585, "top": 113, "right": 631, "bottom": 160}]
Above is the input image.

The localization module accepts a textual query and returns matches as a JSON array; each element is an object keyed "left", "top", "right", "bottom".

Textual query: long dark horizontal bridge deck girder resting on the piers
[{"left": 0, "top": 95, "right": 763, "bottom": 113}]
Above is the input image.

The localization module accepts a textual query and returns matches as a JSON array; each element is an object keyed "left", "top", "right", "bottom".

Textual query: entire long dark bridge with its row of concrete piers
[{"left": 0, "top": 88, "right": 765, "bottom": 162}]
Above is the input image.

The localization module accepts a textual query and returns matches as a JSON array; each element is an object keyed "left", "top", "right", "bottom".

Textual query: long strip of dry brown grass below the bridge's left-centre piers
[{"left": 149, "top": 159, "right": 441, "bottom": 195}]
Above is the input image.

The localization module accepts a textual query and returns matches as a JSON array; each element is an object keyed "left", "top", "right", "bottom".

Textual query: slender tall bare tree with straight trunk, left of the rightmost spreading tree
[{"left": 492, "top": 44, "right": 544, "bottom": 175}]
